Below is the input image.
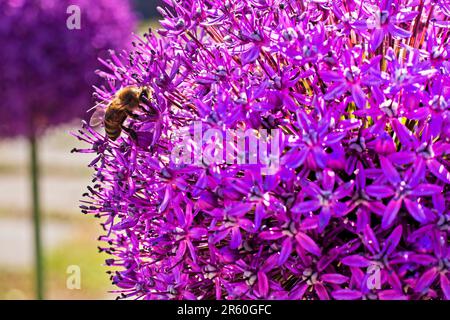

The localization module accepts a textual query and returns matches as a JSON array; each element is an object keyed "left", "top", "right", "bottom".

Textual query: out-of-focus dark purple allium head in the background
[{"left": 0, "top": 0, "right": 135, "bottom": 136}]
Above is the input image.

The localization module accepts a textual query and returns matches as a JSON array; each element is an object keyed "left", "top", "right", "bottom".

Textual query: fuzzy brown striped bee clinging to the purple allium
[{"left": 90, "top": 86, "right": 150, "bottom": 141}]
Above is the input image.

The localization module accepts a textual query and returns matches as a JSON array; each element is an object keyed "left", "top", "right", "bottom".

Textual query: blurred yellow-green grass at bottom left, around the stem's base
[{"left": 0, "top": 217, "right": 115, "bottom": 300}]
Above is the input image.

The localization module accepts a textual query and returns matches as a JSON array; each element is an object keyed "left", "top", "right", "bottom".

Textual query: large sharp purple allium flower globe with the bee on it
[{"left": 78, "top": 0, "right": 450, "bottom": 300}]
